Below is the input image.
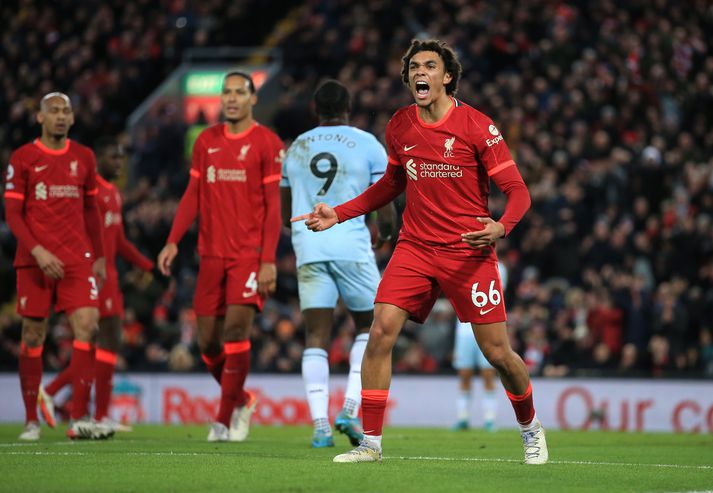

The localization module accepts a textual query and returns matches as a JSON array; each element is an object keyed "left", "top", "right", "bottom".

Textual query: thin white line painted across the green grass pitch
[{"left": 0, "top": 450, "right": 713, "bottom": 470}]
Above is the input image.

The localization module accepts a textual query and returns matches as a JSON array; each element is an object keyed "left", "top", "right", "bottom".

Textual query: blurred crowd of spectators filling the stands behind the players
[{"left": 0, "top": 0, "right": 713, "bottom": 377}]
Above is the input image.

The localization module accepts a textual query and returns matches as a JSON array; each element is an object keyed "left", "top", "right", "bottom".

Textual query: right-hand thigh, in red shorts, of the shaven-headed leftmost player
[{"left": 55, "top": 262, "right": 99, "bottom": 314}]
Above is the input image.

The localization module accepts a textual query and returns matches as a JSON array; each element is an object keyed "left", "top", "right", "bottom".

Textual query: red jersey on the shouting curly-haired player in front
[{"left": 386, "top": 98, "right": 515, "bottom": 252}]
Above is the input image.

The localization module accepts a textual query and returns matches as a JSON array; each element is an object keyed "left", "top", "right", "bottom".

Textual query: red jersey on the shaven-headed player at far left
[{"left": 5, "top": 139, "right": 97, "bottom": 267}]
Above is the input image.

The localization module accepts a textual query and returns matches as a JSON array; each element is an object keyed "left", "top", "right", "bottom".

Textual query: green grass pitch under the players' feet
[{"left": 0, "top": 425, "right": 713, "bottom": 493}]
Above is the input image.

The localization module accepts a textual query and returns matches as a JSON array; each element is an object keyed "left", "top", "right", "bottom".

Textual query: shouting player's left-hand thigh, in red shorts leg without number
[{"left": 374, "top": 242, "right": 441, "bottom": 323}]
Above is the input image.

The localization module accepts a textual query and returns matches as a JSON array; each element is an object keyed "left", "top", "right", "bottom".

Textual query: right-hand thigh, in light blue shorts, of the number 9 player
[{"left": 327, "top": 260, "right": 381, "bottom": 312}]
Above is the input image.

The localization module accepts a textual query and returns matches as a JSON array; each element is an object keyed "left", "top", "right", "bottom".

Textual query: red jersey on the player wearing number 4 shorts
[{"left": 190, "top": 123, "right": 285, "bottom": 258}]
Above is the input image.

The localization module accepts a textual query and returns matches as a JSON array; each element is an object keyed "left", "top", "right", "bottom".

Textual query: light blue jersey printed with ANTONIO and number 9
[{"left": 280, "top": 125, "right": 387, "bottom": 267}]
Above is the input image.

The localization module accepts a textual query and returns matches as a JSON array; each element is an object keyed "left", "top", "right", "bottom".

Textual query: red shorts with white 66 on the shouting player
[{"left": 374, "top": 241, "right": 507, "bottom": 324}]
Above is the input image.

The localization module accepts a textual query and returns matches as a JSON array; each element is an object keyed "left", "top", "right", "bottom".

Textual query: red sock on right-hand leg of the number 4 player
[{"left": 216, "top": 341, "right": 250, "bottom": 426}]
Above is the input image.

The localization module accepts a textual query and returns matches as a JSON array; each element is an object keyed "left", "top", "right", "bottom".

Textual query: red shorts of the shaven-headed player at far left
[{"left": 17, "top": 263, "right": 99, "bottom": 318}]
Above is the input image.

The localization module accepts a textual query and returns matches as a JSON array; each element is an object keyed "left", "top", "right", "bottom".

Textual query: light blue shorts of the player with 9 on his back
[{"left": 297, "top": 260, "right": 381, "bottom": 312}]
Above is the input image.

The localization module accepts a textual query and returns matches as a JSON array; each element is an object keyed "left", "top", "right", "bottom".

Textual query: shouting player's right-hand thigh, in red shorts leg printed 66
[{"left": 437, "top": 257, "right": 507, "bottom": 324}]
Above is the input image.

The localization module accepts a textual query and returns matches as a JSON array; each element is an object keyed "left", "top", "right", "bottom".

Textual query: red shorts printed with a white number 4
[{"left": 193, "top": 257, "right": 265, "bottom": 316}]
